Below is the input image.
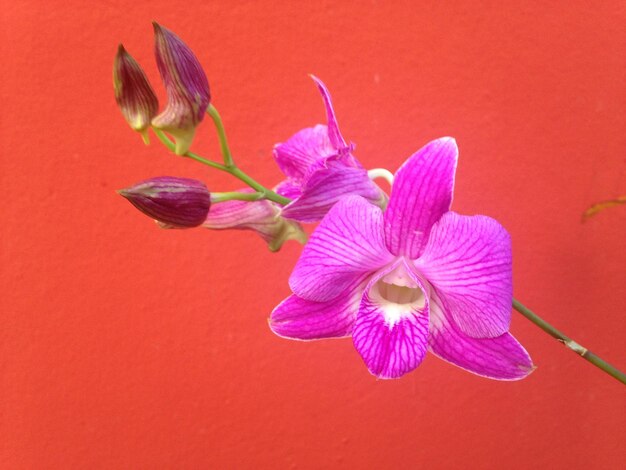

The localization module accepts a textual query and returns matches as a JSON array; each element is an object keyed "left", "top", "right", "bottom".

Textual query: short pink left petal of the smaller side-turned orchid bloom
[{"left": 274, "top": 124, "right": 337, "bottom": 179}]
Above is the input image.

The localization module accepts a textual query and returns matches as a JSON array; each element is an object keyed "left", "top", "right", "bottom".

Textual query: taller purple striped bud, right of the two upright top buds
[{"left": 152, "top": 23, "right": 211, "bottom": 155}]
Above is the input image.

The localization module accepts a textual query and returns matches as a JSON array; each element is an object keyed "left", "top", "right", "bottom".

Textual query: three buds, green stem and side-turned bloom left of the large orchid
[{"left": 113, "top": 23, "right": 387, "bottom": 251}]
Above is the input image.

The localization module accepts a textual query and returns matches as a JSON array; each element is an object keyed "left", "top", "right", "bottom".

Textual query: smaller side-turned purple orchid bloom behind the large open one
[{"left": 274, "top": 76, "right": 387, "bottom": 222}]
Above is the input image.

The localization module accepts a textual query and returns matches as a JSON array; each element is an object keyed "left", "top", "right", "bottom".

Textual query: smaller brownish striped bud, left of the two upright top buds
[{"left": 113, "top": 44, "right": 159, "bottom": 144}]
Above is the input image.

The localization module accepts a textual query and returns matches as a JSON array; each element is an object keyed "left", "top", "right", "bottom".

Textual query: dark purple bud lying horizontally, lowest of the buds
[{"left": 118, "top": 176, "right": 211, "bottom": 228}]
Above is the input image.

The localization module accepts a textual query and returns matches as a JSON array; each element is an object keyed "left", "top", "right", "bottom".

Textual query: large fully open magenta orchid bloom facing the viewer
[{"left": 270, "top": 138, "right": 533, "bottom": 380}]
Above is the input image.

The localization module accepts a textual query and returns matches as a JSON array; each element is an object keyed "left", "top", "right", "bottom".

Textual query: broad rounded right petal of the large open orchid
[{"left": 415, "top": 212, "right": 513, "bottom": 338}]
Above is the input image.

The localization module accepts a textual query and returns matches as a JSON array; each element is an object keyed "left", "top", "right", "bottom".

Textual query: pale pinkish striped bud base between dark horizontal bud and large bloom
[{"left": 202, "top": 188, "right": 307, "bottom": 251}]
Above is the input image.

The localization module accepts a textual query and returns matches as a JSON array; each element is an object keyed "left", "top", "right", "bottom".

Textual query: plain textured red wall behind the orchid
[{"left": 0, "top": 0, "right": 626, "bottom": 469}]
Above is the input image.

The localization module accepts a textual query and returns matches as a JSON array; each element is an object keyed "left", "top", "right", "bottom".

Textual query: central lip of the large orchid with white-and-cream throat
[{"left": 352, "top": 261, "right": 428, "bottom": 379}]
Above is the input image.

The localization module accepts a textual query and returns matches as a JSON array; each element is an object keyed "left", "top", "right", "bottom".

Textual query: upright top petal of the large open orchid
[{"left": 385, "top": 137, "right": 458, "bottom": 259}]
